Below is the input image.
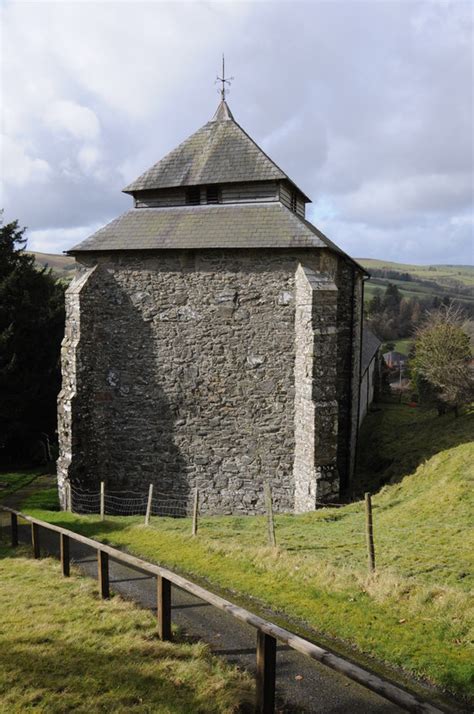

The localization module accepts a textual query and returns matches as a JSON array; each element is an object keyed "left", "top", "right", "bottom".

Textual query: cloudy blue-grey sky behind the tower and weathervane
[{"left": 0, "top": 0, "right": 474, "bottom": 264}]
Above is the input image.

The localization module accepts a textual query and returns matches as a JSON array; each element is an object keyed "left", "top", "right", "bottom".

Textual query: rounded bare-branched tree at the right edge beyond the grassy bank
[{"left": 411, "top": 302, "right": 474, "bottom": 416}]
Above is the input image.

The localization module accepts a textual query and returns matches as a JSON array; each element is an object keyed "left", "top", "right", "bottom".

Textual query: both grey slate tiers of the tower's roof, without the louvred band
[{"left": 66, "top": 101, "right": 366, "bottom": 273}]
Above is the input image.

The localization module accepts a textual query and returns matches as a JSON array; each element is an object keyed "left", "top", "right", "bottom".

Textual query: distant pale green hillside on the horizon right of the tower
[{"left": 357, "top": 258, "right": 474, "bottom": 314}]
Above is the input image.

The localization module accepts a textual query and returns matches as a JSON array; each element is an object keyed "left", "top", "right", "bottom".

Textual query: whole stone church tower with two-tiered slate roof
[{"left": 58, "top": 101, "right": 364, "bottom": 513}]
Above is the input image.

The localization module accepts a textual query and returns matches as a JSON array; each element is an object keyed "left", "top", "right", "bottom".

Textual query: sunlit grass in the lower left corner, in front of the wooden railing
[{"left": 0, "top": 546, "right": 252, "bottom": 714}]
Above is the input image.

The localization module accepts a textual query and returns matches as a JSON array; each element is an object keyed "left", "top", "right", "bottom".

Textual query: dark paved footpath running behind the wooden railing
[{"left": 1, "top": 477, "right": 452, "bottom": 714}]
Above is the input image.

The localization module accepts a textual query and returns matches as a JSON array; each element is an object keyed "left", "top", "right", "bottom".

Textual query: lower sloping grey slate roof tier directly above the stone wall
[{"left": 67, "top": 202, "right": 334, "bottom": 255}]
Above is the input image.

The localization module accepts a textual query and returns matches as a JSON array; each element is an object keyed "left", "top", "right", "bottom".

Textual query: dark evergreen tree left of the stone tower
[{"left": 0, "top": 221, "right": 64, "bottom": 463}]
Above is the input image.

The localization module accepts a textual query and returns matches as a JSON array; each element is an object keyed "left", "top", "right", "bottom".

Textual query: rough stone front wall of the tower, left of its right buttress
[{"left": 58, "top": 249, "right": 362, "bottom": 513}]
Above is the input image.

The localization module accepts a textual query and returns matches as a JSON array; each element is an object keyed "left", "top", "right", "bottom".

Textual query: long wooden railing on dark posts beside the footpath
[{"left": 0, "top": 506, "right": 442, "bottom": 714}]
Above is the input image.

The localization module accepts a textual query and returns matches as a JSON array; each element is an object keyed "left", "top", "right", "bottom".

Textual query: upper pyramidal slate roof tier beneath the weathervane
[{"left": 123, "top": 100, "right": 309, "bottom": 201}]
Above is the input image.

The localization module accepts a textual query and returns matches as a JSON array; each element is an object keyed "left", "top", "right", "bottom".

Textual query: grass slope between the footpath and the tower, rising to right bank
[{"left": 20, "top": 405, "right": 474, "bottom": 697}]
